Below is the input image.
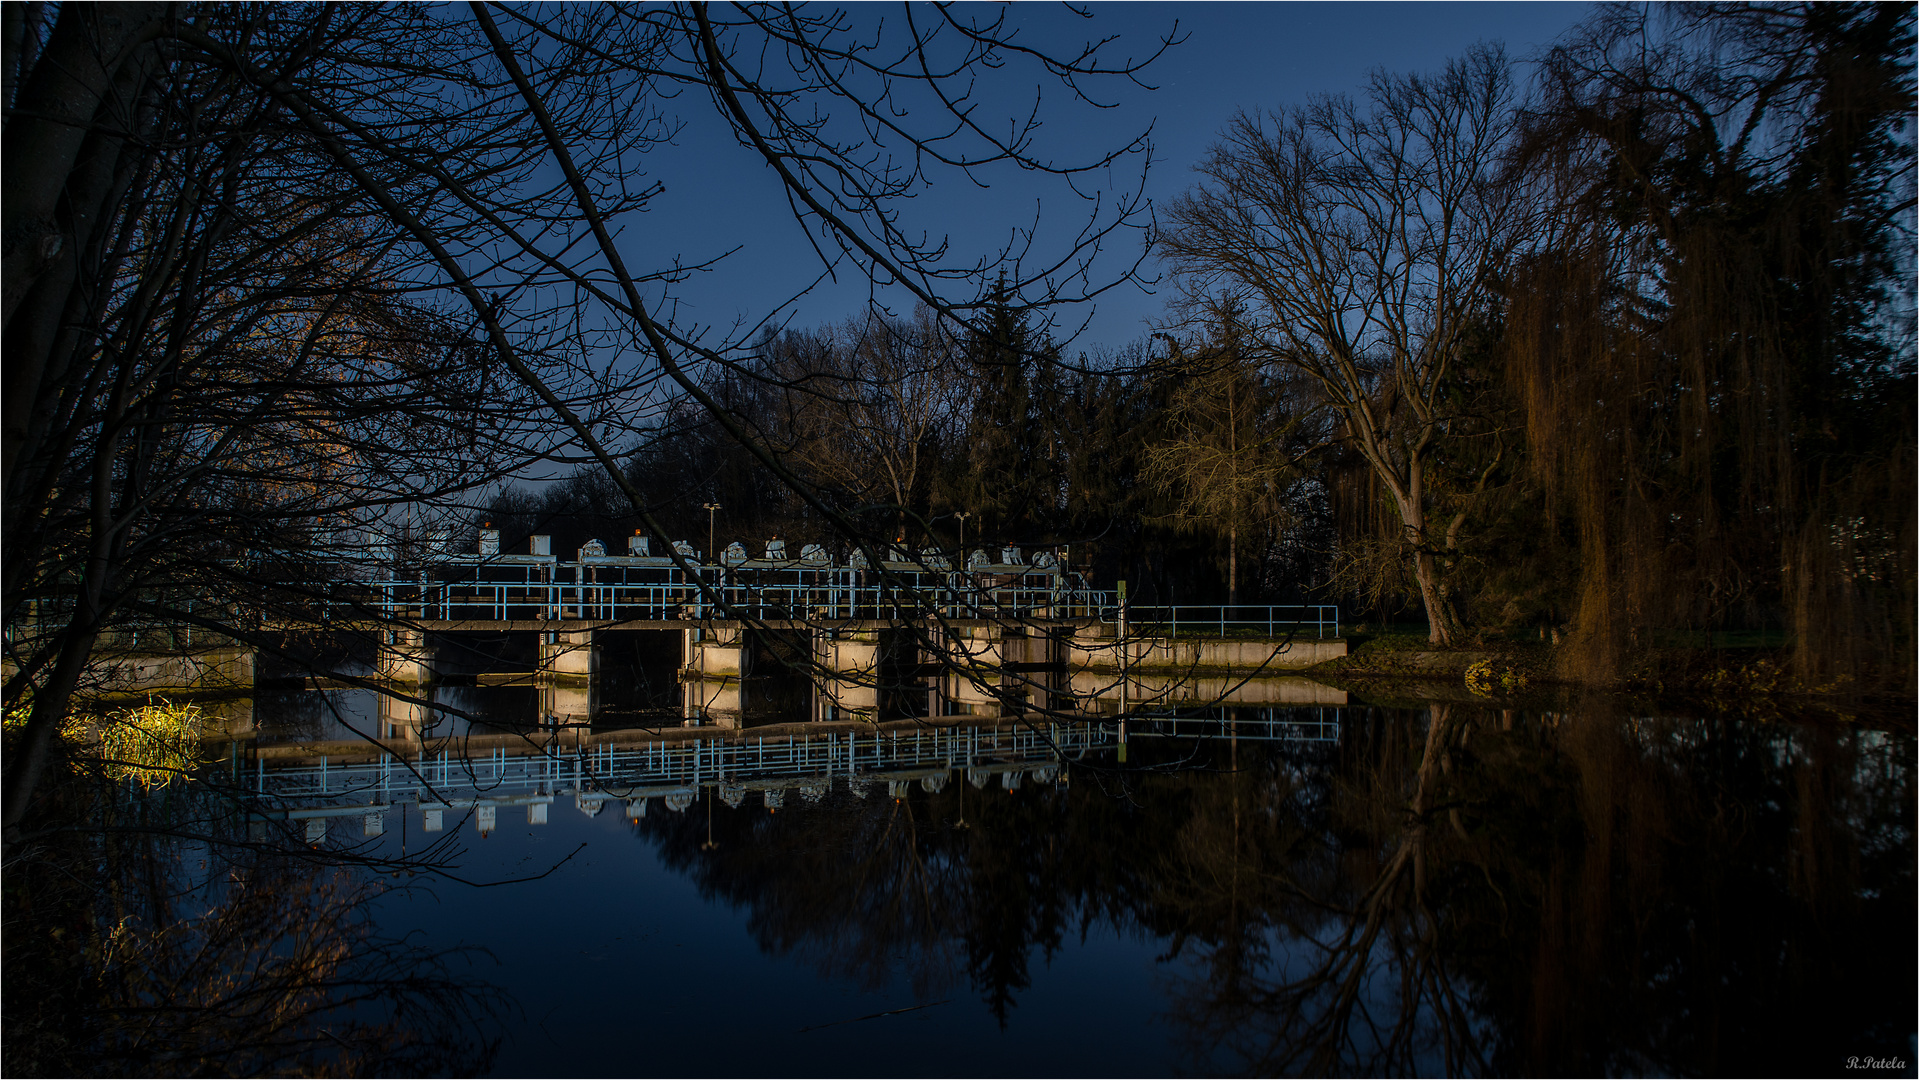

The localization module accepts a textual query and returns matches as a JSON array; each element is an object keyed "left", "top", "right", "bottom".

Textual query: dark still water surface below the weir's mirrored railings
[{"left": 232, "top": 689, "right": 1919, "bottom": 1076}]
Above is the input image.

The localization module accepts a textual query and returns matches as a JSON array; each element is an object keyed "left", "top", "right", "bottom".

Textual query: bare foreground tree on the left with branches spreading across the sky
[{"left": 0, "top": 4, "right": 1146, "bottom": 827}]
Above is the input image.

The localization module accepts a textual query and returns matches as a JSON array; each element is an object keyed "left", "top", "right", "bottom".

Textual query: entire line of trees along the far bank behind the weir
[{"left": 472, "top": 4, "right": 1919, "bottom": 693}]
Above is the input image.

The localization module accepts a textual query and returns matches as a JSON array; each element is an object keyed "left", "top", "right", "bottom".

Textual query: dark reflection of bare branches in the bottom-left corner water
[{"left": 4, "top": 763, "right": 499, "bottom": 1076}]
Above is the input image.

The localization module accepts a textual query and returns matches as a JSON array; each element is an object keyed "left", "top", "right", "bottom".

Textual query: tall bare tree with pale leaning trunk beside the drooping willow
[{"left": 1161, "top": 48, "right": 1529, "bottom": 643}]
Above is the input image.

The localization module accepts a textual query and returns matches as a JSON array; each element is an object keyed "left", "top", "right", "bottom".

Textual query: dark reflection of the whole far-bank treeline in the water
[{"left": 639, "top": 706, "right": 1915, "bottom": 1072}]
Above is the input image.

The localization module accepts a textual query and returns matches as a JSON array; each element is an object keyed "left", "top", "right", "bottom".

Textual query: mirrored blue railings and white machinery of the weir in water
[{"left": 234, "top": 708, "right": 1339, "bottom": 842}]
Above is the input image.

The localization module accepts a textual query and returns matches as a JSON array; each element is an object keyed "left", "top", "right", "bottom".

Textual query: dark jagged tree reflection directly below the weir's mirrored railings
[{"left": 637, "top": 748, "right": 1289, "bottom": 1022}]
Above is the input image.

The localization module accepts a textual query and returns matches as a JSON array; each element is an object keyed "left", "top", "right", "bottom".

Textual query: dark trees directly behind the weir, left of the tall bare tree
[{"left": 483, "top": 301, "right": 1332, "bottom": 602}]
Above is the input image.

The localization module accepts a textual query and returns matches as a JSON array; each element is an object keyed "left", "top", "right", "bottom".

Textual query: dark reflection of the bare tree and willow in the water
[{"left": 1143, "top": 706, "right": 1915, "bottom": 1074}]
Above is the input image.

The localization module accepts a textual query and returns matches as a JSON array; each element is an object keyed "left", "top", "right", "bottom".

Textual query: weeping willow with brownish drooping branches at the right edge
[{"left": 1506, "top": 4, "right": 1915, "bottom": 687}]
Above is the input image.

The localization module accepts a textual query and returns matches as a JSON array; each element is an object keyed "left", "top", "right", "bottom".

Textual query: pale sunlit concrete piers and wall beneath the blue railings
[{"left": 67, "top": 618, "right": 1347, "bottom": 731}]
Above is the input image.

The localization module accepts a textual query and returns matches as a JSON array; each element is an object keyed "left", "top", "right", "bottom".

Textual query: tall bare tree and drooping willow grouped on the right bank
[{"left": 1163, "top": 4, "right": 1915, "bottom": 691}]
